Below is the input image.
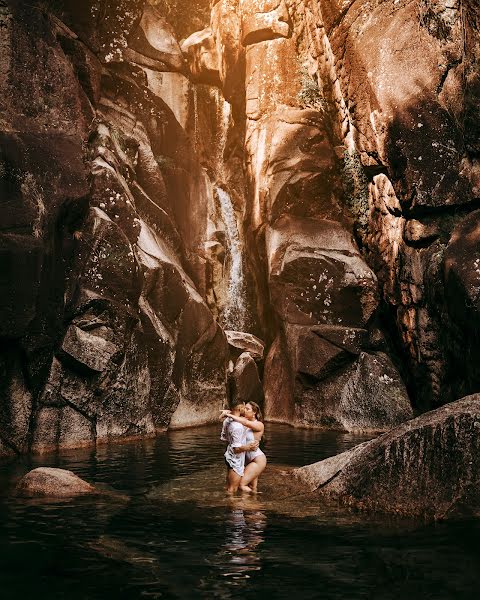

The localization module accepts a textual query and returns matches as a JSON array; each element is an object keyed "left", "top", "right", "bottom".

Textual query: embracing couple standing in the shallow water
[{"left": 220, "top": 400, "right": 267, "bottom": 494}]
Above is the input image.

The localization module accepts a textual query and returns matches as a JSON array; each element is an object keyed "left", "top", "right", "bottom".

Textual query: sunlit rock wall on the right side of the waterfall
[{"left": 187, "top": 0, "right": 480, "bottom": 429}]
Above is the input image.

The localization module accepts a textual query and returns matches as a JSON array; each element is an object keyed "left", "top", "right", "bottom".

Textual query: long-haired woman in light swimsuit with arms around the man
[{"left": 222, "top": 402, "right": 267, "bottom": 494}]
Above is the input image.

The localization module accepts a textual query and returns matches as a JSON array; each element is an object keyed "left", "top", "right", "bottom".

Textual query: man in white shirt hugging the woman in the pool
[{"left": 220, "top": 400, "right": 258, "bottom": 494}]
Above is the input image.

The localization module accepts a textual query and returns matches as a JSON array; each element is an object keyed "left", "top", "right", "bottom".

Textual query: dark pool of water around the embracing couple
[{"left": 0, "top": 425, "right": 480, "bottom": 600}]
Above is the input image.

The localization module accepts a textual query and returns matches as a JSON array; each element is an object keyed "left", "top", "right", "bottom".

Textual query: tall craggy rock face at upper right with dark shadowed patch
[{"left": 306, "top": 0, "right": 480, "bottom": 410}]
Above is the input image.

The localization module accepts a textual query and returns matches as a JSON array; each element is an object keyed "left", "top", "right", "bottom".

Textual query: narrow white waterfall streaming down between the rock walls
[{"left": 216, "top": 187, "right": 247, "bottom": 331}]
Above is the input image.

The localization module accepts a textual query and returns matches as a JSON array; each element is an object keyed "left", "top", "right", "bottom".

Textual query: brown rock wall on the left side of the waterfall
[{"left": 0, "top": 0, "right": 227, "bottom": 454}]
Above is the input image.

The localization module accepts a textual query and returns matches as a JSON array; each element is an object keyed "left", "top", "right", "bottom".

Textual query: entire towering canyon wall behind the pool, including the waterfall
[{"left": 0, "top": 0, "right": 480, "bottom": 454}]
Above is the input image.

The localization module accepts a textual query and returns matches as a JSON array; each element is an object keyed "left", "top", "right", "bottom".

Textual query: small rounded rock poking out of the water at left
[{"left": 16, "top": 467, "right": 95, "bottom": 498}]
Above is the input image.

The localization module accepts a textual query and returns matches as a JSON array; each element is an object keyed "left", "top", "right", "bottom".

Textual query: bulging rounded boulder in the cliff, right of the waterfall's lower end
[{"left": 267, "top": 217, "right": 378, "bottom": 328}]
